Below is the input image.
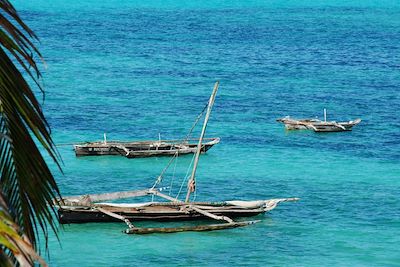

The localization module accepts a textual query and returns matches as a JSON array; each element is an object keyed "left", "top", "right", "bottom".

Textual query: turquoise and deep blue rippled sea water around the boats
[{"left": 13, "top": 0, "right": 400, "bottom": 266}]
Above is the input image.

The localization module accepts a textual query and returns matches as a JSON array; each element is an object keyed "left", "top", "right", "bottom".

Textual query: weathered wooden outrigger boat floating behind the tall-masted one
[{"left": 74, "top": 137, "right": 220, "bottom": 158}]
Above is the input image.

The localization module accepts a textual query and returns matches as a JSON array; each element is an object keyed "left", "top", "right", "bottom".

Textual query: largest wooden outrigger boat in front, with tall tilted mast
[{"left": 55, "top": 82, "right": 298, "bottom": 234}]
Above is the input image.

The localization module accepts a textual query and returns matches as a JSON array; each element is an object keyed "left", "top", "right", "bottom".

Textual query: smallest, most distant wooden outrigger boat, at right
[{"left": 276, "top": 109, "right": 361, "bottom": 132}]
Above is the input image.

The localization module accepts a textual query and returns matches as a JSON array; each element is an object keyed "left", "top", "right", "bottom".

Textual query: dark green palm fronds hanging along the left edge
[{"left": 0, "top": 0, "right": 61, "bottom": 262}]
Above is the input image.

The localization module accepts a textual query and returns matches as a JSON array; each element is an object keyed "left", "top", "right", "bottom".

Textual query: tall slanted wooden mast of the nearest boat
[{"left": 185, "top": 81, "right": 219, "bottom": 202}]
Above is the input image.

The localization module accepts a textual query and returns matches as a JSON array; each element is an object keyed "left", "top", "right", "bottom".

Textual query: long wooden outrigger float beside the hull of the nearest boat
[{"left": 125, "top": 220, "right": 259, "bottom": 234}]
